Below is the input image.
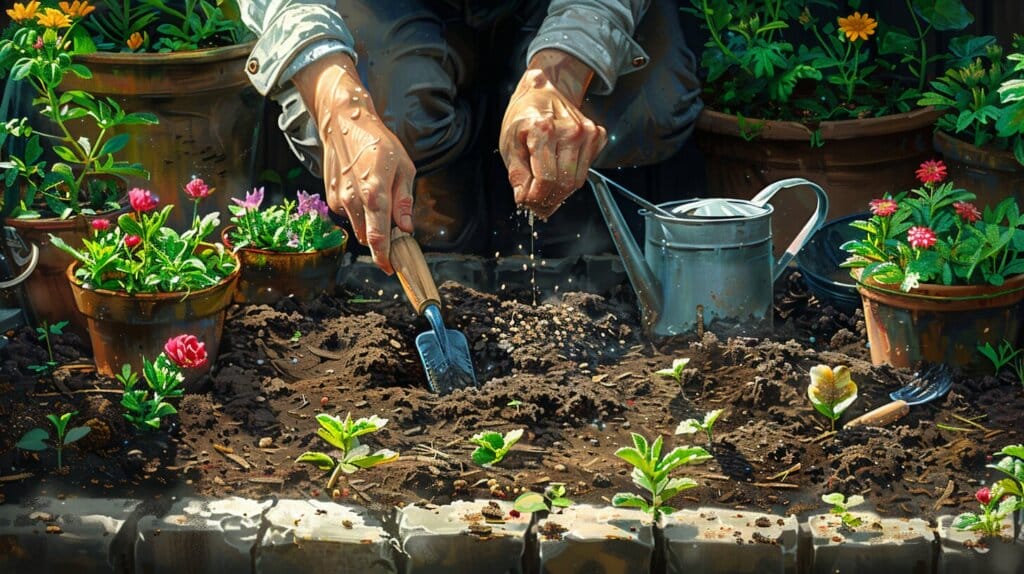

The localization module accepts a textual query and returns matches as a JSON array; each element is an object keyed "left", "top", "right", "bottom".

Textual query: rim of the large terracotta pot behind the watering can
[{"left": 696, "top": 106, "right": 943, "bottom": 141}]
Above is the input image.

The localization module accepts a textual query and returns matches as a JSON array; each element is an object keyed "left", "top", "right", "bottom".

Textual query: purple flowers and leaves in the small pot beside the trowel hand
[{"left": 227, "top": 187, "right": 345, "bottom": 253}]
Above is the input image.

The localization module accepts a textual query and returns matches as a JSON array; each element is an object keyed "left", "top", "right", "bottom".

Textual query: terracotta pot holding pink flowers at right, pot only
[{"left": 857, "top": 274, "right": 1024, "bottom": 371}]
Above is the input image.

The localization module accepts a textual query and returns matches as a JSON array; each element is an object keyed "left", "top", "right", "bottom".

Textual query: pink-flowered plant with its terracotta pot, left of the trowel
[{"left": 51, "top": 180, "right": 241, "bottom": 383}]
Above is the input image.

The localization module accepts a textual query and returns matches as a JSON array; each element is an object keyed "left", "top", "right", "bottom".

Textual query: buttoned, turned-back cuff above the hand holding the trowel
[{"left": 246, "top": 4, "right": 356, "bottom": 95}]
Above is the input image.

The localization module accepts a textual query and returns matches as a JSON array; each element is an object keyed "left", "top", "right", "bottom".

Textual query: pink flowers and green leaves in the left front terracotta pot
[{"left": 50, "top": 178, "right": 238, "bottom": 294}]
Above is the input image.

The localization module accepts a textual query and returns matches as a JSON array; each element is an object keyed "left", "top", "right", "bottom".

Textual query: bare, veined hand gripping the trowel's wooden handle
[{"left": 294, "top": 53, "right": 416, "bottom": 274}]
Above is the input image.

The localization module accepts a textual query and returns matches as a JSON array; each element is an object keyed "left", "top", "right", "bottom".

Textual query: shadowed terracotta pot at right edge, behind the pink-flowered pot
[{"left": 932, "top": 131, "right": 1024, "bottom": 207}]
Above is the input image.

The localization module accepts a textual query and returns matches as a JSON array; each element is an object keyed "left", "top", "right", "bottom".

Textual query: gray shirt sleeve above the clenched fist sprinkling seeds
[{"left": 526, "top": 0, "right": 650, "bottom": 94}]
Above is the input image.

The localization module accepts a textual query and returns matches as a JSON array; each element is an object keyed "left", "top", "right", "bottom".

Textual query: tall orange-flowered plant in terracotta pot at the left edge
[{"left": 0, "top": 0, "right": 157, "bottom": 337}]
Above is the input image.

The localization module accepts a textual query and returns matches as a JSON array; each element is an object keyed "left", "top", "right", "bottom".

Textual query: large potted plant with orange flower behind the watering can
[{"left": 684, "top": 0, "right": 973, "bottom": 245}]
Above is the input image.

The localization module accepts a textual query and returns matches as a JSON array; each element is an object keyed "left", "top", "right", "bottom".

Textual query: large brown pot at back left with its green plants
[{"left": 58, "top": 0, "right": 264, "bottom": 230}]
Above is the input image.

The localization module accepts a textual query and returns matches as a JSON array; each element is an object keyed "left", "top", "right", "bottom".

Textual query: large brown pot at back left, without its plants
[{"left": 61, "top": 42, "right": 264, "bottom": 231}]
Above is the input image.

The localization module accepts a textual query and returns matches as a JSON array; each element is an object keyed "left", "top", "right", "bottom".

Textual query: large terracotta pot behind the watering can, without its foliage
[{"left": 689, "top": 107, "right": 942, "bottom": 252}]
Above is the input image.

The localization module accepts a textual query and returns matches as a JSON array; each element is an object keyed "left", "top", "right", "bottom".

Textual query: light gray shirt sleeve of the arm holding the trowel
[{"left": 239, "top": 0, "right": 356, "bottom": 95}]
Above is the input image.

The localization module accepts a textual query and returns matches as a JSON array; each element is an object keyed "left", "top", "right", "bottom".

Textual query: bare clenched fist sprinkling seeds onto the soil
[{"left": 499, "top": 49, "right": 607, "bottom": 219}]
